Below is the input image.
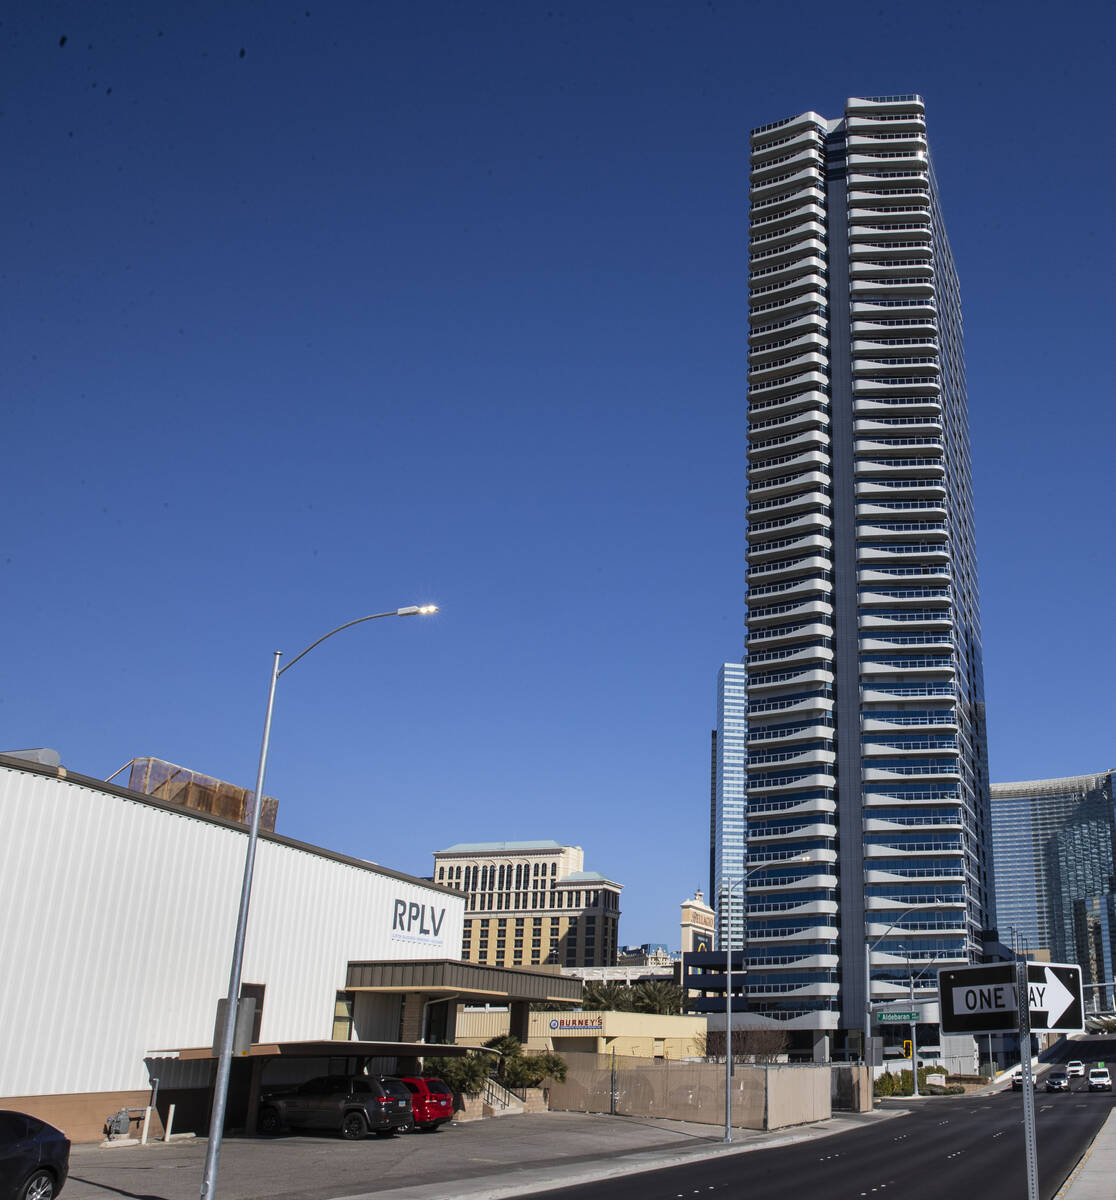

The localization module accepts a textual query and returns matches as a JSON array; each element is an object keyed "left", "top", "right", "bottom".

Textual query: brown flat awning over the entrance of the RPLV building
[{"left": 344, "top": 959, "right": 582, "bottom": 1004}]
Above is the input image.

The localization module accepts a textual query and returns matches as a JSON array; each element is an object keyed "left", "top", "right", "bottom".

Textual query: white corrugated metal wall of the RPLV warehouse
[{"left": 0, "top": 767, "right": 463, "bottom": 1096}]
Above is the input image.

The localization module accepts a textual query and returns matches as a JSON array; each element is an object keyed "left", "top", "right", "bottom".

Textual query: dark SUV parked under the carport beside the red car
[{"left": 257, "top": 1075, "right": 415, "bottom": 1140}]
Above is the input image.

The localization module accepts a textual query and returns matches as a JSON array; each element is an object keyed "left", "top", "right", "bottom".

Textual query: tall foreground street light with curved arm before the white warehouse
[{"left": 200, "top": 605, "right": 438, "bottom": 1200}]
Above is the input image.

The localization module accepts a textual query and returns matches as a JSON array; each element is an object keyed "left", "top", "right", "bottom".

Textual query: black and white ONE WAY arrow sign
[{"left": 937, "top": 962, "right": 1085, "bottom": 1033}]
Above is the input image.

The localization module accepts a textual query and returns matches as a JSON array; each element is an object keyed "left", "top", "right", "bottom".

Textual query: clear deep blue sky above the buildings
[{"left": 0, "top": 0, "right": 1116, "bottom": 944}]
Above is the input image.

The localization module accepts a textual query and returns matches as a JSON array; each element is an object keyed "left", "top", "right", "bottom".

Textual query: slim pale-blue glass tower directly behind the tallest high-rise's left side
[{"left": 709, "top": 662, "right": 748, "bottom": 949}]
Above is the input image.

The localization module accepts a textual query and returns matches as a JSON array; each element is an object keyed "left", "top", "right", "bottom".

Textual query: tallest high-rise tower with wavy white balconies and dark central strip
[{"left": 714, "top": 95, "right": 995, "bottom": 1055}]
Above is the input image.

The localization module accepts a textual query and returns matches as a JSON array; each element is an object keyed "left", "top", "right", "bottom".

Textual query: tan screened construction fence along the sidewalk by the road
[{"left": 550, "top": 1054, "right": 854, "bottom": 1129}]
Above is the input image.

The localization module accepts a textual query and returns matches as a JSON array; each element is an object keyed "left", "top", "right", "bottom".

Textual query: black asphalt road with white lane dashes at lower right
[{"left": 508, "top": 1056, "right": 1116, "bottom": 1200}]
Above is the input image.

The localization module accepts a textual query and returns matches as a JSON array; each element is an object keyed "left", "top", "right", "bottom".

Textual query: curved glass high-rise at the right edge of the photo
[{"left": 991, "top": 772, "right": 1116, "bottom": 1010}]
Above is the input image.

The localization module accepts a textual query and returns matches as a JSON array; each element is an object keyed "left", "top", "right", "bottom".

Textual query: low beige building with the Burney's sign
[{"left": 457, "top": 1009, "right": 706, "bottom": 1058}]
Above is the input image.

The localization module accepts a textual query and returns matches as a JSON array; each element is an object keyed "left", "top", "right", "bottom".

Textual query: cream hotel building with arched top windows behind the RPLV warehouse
[{"left": 434, "top": 841, "right": 622, "bottom": 967}]
